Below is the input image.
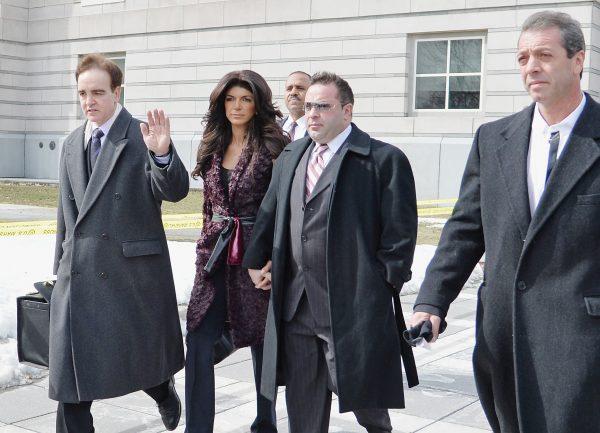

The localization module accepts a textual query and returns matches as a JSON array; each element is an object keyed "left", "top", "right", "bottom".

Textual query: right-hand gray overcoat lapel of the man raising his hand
[{"left": 77, "top": 108, "right": 131, "bottom": 223}]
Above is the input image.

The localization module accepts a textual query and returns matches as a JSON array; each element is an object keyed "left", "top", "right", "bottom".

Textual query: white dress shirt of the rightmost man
[{"left": 527, "top": 94, "right": 585, "bottom": 216}]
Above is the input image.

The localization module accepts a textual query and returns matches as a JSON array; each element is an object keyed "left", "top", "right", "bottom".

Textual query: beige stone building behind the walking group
[{"left": 0, "top": 0, "right": 600, "bottom": 199}]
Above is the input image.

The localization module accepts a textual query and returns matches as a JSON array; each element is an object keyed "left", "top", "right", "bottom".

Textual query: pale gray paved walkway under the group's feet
[{"left": 0, "top": 289, "right": 490, "bottom": 433}]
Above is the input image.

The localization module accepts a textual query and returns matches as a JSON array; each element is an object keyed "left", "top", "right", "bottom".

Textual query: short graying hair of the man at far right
[{"left": 521, "top": 11, "right": 585, "bottom": 58}]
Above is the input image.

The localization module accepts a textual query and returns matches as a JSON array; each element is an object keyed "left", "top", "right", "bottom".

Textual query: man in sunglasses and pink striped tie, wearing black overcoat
[{"left": 243, "top": 72, "right": 417, "bottom": 433}]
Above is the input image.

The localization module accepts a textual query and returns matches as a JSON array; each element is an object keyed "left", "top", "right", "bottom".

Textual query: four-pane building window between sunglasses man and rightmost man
[{"left": 414, "top": 38, "right": 483, "bottom": 110}]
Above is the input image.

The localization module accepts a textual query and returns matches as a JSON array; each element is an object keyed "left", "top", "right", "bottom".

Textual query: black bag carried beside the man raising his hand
[{"left": 17, "top": 281, "right": 55, "bottom": 368}]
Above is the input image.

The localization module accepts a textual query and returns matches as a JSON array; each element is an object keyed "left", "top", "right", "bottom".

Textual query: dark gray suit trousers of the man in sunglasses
[{"left": 283, "top": 294, "right": 392, "bottom": 433}]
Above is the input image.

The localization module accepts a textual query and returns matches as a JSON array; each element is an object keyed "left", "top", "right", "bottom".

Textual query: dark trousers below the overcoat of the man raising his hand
[{"left": 56, "top": 381, "right": 169, "bottom": 433}]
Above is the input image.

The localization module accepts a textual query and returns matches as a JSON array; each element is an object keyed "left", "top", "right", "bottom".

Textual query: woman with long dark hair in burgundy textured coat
[{"left": 185, "top": 70, "right": 289, "bottom": 433}]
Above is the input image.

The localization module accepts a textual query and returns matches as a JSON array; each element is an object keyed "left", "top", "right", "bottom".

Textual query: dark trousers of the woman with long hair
[{"left": 185, "top": 272, "right": 277, "bottom": 433}]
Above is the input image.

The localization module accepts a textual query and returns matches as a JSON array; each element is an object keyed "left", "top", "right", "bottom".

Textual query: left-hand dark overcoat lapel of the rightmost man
[{"left": 496, "top": 104, "right": 535, "bottom": 239}]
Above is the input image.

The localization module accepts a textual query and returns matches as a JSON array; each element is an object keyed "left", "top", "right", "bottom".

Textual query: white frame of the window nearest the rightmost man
[{"left": 411, "top": 35, "right": 486, "bottom": 113}]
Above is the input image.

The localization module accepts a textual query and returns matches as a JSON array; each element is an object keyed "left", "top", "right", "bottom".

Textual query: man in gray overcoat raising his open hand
[{"left": 49, "top": 54, "right": 189, "bottom": 433}]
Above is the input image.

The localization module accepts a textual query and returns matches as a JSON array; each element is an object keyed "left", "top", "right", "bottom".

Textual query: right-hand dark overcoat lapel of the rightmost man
[{"left": 527, "top": 95, "right": 600, "bottom": 243}]
